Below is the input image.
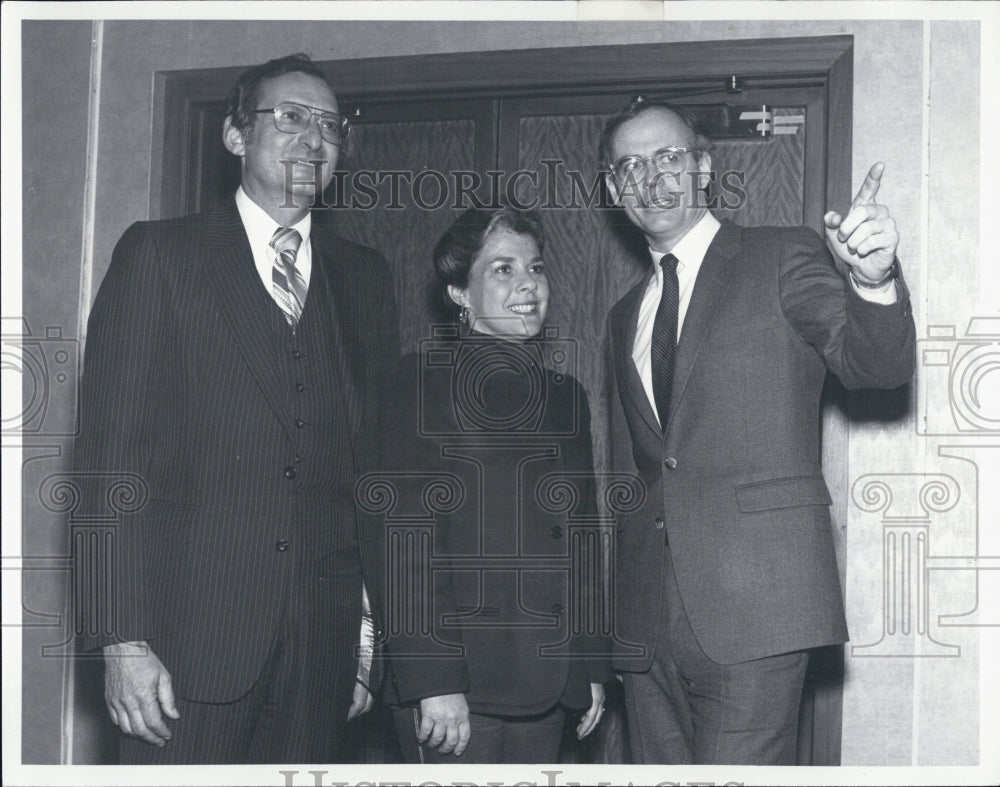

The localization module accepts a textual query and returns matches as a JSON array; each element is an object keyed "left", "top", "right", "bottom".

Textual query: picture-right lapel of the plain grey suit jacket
[{"left": 667, "top": 221, "right": 740, "bottom": 431}]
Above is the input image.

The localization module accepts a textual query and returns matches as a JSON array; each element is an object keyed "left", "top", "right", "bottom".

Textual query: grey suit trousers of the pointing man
[{"left": 625, "top": 555, "right": 808, "bottom": 765}]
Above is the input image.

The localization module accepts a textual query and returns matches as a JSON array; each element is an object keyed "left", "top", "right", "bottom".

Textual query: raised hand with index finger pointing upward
[{"left": 823, "top": 161, "right": 899, "bottom": 282}]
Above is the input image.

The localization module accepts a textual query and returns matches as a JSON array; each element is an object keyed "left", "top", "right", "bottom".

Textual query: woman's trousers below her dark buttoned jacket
[{"left": 392, "top": 705, "right": 566, "bottom": 764}]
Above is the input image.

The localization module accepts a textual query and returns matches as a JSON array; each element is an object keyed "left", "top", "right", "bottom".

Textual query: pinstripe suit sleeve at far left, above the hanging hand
[{"left": 74, "top": 224, "right": 167, "bottom": 650}]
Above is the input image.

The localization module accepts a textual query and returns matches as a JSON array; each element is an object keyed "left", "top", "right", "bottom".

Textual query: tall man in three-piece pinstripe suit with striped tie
[{"left": 76, "top": 55, "right": 398, "bottom": 763}]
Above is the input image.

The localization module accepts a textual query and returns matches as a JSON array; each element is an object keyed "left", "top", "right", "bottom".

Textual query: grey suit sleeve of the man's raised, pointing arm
[{"left": 779, "top": 229, "right": 916, "bottom": 389}]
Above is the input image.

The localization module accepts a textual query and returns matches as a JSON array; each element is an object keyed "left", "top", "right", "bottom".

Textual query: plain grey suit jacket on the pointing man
[{"left": 608, "top": 221, "right": 915, "bottom": 671}]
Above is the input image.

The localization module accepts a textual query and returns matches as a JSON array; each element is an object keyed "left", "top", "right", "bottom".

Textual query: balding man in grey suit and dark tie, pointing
[{"left": 601, "top": 102, "right": 914, "bottom": 764}]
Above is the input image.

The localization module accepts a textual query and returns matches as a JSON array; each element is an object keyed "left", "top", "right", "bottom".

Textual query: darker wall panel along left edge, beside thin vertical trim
[{"left": 20, "top": 22, "right": 92, "bottom": 762}]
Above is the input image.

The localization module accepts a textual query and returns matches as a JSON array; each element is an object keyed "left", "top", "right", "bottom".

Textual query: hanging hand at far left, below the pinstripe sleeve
[{"left": 104, "top": 642, "right": 181, "bottom": 746}]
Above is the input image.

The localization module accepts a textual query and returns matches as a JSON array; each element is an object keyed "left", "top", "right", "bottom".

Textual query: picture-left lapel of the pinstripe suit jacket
[{"left": 204, "top": 199, "right": 294, "bottom": 444}]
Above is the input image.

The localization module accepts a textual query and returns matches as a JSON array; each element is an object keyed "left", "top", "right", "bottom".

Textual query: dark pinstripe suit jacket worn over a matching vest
[{"left": 76, "top": 199, "right": 399, "bottom": 702}]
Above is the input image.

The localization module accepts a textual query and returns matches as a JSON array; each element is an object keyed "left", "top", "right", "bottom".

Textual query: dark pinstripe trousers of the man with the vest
[{"left": 120, "top": 567, "right": 361, "bottom": 765}]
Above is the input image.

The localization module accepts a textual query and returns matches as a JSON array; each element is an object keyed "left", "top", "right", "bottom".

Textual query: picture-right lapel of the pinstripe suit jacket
[{"left": 311, "top": 231, "right": 365, "bottom": 442}]
